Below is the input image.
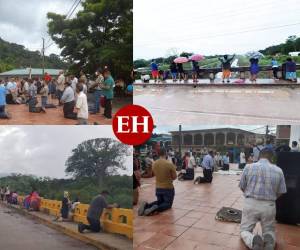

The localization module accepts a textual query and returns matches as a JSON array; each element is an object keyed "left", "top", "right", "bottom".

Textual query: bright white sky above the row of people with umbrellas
[{"left": 134, "top": 0, "right": 300, "bottom": 59}]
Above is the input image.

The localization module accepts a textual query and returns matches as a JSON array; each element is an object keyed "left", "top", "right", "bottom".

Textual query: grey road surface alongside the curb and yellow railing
[{"left": 0, "top": 205, "right": 96, "bottom": 250}]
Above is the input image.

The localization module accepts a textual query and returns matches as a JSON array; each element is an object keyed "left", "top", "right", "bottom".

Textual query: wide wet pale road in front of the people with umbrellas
[{"left": 134, "top": 86, "right": 300, "bottom": 125}]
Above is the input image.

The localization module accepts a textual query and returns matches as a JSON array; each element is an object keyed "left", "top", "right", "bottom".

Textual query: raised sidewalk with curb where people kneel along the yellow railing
[{"left": 0, "top": 203, "right": 132, "bottom": 250}]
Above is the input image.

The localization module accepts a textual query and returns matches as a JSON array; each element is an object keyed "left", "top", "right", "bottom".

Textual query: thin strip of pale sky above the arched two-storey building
[{"left": 154, "top": 125, "right": 276, "bottom": 134}]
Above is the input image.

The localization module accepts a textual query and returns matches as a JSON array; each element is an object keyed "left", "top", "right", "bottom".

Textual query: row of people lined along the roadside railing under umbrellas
[{"left": 146, "top": 55, "right": 297, "bottom": 83}]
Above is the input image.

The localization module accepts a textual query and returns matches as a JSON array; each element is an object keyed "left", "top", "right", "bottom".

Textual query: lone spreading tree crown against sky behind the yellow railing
[{"left": 65, "top": 138, "right": 130, "bottom": 185}]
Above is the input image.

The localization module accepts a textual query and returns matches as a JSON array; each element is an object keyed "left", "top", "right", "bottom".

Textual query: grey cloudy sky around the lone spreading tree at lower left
[{"left": 0, "top": 126, "right": 132, "bottom": 178}]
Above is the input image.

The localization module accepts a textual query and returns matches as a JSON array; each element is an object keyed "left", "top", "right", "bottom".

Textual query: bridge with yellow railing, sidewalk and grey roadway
[{"left": 0, "top": 196, "right": 133, "bottom": 250}]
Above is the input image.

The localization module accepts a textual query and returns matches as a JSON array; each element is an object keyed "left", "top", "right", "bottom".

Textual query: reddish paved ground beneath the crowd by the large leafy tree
[{"left": 0, "top": 95, "right": 132, "bottom": 125}]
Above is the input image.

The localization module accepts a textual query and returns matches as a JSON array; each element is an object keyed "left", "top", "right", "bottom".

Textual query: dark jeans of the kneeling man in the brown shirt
[{"left": 145, "top": 188, "right": 175, "bottom": 212}]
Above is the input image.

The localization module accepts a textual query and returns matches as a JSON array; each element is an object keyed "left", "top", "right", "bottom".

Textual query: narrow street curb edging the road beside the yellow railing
[{"left": 1, "top": 202, "right": 130, "bottom": 250}]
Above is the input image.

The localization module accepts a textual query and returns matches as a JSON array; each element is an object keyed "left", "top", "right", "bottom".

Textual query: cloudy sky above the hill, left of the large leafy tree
[{"left": 0, "top": 0, "right": 81, "bottom": 55}]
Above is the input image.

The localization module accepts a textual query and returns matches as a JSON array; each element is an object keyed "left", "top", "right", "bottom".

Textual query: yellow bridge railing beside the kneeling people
[{"left": 18, "top": 196, "right": 133, "bottom": 239}]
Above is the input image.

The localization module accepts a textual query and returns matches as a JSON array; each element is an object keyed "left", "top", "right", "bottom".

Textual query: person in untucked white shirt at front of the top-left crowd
[{"left": 76, "top": 83, "right": 89, "bottom": 125}]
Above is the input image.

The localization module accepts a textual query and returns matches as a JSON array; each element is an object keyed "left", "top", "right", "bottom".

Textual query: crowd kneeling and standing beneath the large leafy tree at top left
[{"left": 0, "top": 67, "right": 115, "bottom": 122}]
